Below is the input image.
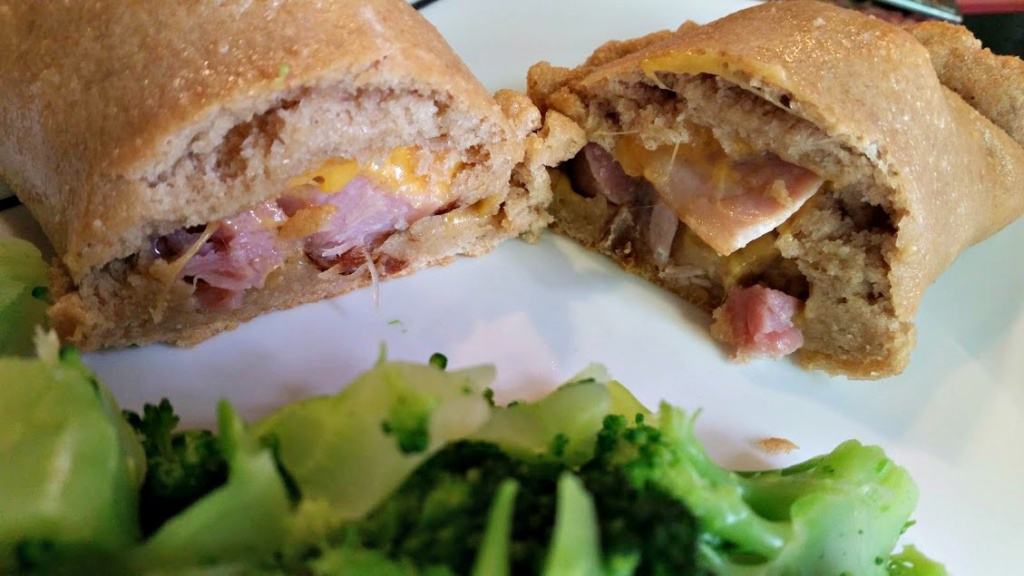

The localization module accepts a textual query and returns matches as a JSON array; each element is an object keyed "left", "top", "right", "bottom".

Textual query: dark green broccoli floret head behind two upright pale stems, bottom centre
[{"left": 311, "top": 442, "right": 697, "bottom": 574}]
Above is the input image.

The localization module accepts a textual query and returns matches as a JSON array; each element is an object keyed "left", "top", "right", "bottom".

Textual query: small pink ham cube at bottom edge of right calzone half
[{"left": 712, "top": 285, "right": 804, "bottom": 359}]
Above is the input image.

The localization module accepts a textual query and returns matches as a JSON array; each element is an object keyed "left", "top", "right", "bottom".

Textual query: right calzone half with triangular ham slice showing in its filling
[{"left": 529, "top": 1, "right": 1024, "bottom": 378}]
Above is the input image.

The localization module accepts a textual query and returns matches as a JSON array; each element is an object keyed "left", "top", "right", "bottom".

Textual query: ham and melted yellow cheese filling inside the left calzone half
[{"left": 143, "top": 148, "right": 461, "bottom": 310}]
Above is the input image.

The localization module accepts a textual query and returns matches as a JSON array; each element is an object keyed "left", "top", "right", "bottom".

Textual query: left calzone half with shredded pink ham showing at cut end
[{"left": 0, "top": 0, "right": 583, "bottom": 348}]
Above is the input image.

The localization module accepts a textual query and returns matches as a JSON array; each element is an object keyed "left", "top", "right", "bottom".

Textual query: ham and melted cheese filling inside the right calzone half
[{"left": 569, "top": 135, "right": 825, "bottom": 357}]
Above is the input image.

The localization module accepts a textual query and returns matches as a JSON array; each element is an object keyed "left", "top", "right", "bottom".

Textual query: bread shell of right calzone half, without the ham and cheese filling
[{"left": 528, "top": 0, "right": 1024, "bottom": 378}]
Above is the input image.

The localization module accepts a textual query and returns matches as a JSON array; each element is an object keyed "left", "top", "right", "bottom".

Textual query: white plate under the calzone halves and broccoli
[{"left": 0, "top": 0, "right": 1024, "bottom": 575}]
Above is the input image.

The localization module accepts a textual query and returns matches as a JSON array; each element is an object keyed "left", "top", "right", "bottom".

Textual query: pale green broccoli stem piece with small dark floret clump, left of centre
[{"left": 255, "top": 362, "right": 494, "bottom": 521}]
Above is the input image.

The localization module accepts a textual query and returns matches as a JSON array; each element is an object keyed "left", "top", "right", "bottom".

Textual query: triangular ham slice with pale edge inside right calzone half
[{"left": 644, "top": 148, "right": 824, "bottom": 256}]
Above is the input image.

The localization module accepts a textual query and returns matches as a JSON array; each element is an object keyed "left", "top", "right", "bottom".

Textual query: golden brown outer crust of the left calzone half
[{"left": 0, "top": 0, "right": 514, "bottom": 279}]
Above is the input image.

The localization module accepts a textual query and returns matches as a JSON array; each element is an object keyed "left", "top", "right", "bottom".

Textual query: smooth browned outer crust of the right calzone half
[{"left": 528, "top": 0, "right": 1024, "bottom": 377}]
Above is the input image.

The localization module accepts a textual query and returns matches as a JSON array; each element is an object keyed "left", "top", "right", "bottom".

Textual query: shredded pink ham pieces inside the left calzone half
[{"left": 150, "top": 172, "right": 439, "bottom": 310}]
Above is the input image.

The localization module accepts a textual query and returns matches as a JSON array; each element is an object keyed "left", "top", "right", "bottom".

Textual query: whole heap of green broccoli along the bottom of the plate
[{"left": 0, "top": 350, "right": 944, "bottom": 576}]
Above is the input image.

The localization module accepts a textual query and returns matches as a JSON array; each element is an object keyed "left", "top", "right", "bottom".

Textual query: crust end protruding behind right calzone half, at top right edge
[{"left": 909, "top": 22, "right": 1024, "bottom": 145}]
